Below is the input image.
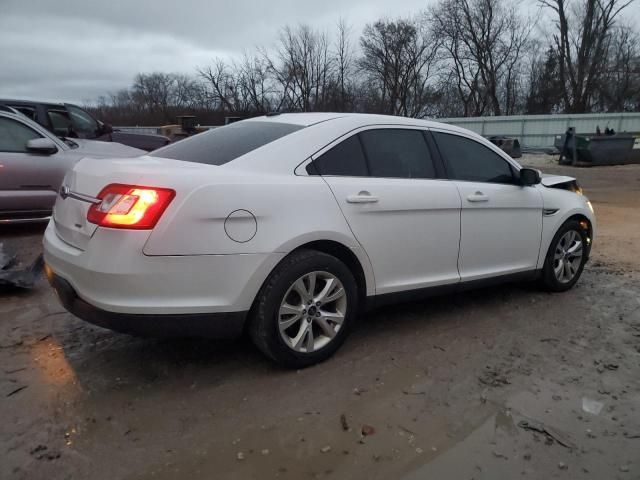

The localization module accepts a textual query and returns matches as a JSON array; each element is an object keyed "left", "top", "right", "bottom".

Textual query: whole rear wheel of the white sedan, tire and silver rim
[{"left": 249, "top": 250, "right": 358, "bottom": 368}]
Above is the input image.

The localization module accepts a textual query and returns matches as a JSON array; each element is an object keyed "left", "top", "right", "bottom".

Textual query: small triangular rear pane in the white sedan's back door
[{"left": 307, "top": 135, "right": 369, "bottom": 177}]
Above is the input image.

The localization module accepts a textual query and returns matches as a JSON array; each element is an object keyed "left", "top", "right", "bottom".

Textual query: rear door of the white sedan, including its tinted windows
[{"left": 311, "top": 126, "right": 460, "bottom": 294}]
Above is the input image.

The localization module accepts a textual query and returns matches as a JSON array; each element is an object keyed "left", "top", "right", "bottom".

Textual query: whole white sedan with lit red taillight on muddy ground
[{"left": 44, "top": 113, "right": 595, "bottom": 367}]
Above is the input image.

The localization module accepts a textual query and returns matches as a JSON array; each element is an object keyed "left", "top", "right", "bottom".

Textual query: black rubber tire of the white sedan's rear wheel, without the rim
[{"left": 248, "top": 250, "right": 358, "bottom": 368}]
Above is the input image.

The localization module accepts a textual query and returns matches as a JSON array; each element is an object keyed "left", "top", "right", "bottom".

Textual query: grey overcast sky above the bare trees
[{"left": 0, "top": 0, "right": 640, "bottom": 103}]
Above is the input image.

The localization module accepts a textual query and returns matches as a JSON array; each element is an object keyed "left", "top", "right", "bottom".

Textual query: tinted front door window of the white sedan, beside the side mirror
[{"left": 433, "top": 132, "right": 515, "bottom": 184}]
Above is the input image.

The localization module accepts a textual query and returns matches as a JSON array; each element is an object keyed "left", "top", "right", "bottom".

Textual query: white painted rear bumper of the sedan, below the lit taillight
[{"left": 44, "top": 220, "right": 284, "bottom": 321}]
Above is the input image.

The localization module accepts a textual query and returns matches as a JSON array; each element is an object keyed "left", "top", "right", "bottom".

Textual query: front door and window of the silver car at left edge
[{"left": 0, "top": 116, "right": 66, "bottom": 212}]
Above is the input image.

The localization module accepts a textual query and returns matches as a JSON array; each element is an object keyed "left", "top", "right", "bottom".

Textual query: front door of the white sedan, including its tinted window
[{"left": 433, "top": 131, "right": 542, "bottom": 282}]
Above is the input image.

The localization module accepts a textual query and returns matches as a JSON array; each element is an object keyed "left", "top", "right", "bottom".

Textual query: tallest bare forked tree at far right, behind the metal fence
[{"left": 539, "top": 0, "right": 633, "bottom": 113}]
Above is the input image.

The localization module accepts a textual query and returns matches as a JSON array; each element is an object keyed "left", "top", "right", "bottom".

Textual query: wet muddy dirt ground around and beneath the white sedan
[{"left": 0, "top": 157, "right": 640, "bottom": 480}]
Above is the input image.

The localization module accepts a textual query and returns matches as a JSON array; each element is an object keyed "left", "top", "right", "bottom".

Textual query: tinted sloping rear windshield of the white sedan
[{"left": 150, "top": 121, "right": 303, "bottom": 165}]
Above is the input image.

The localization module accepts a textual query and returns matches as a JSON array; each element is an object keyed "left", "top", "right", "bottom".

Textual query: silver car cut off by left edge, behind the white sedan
[{"left": 0, "top": 108, "right": 142, "bottom": 223}]
